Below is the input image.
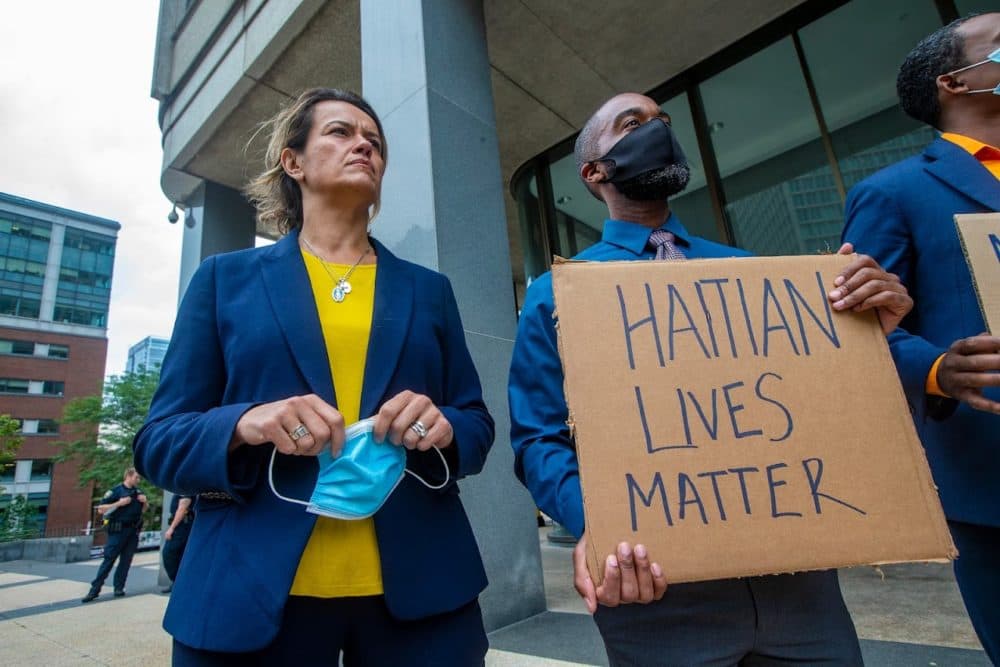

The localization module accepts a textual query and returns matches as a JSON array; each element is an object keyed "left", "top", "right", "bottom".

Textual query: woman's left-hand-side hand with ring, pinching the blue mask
[{"left": 229, "top": 394, "right": 344, "bottom": 456}]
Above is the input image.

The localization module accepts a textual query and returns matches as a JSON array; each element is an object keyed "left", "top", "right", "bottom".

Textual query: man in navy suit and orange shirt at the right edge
[{"left": 844, "top": 13, "right": 1000, "bottom": 663}]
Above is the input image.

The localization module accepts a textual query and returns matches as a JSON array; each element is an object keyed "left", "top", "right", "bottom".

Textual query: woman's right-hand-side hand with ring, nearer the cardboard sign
[{"left": 372, "top": 391, "right": 455, "bottom": 451}]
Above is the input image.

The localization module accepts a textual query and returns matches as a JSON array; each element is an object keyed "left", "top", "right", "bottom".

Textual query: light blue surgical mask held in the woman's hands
[{"left": 267, "top": 417, "right": 450, "bottom": 519}]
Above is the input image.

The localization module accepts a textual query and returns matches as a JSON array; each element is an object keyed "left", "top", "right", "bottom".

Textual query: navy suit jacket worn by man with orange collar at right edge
[{"left": 844, "top": 139, "right": 1000, "bottom": 526}]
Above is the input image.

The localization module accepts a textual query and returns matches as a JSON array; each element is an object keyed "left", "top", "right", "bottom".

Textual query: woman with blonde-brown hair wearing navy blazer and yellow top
[{"left": 133, "top": 89, "right": 494, "bottom": 665}]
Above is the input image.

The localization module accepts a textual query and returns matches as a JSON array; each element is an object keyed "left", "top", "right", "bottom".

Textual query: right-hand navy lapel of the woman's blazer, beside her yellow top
[{"left": 361, "top": 239, "right": 413, "bottom": 418}]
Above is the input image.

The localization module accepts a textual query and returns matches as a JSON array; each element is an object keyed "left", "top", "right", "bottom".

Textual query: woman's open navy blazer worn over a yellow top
[{"left": 133, "top": 233, "right": 493, "bottom": 651}]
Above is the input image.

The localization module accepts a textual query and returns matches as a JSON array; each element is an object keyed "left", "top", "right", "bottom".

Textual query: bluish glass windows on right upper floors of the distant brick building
[{"left": 52, "top": 229, "right": 115, "bottom": 327}]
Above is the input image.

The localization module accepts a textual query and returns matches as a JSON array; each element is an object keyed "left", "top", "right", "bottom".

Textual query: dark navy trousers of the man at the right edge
[{"left": 948, "top": 521, "right": 1000, "bottom": 665}]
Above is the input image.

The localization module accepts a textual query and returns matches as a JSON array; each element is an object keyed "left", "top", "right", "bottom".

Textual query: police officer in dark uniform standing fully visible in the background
[{"left": 81, "top": 468, "right": 147, "bottom": 602}]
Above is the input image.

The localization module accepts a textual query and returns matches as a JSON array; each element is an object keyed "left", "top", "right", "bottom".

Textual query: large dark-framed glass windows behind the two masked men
[{"left": 511, "top": 0, "right": 964, "bottom": 283}]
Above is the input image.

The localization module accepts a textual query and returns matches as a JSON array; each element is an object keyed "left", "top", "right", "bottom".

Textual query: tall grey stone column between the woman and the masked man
[{"left": 361, "top": 0, "right": 545, "bottom": 630}]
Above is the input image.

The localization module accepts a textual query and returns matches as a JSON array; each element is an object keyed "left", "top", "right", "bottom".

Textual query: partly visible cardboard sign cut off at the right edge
[{"left": 955, "top": 213, "right": 1000, "bottom": 336}]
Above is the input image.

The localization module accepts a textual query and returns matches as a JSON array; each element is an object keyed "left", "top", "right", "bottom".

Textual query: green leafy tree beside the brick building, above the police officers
[{"left": 56, "top": 370, "right": 163, "bottom": 525}]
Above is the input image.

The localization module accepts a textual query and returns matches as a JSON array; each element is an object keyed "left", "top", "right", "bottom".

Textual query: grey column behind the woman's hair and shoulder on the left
[{"left": 159, "top": 181, "right": 257, "bottom": 586}]
